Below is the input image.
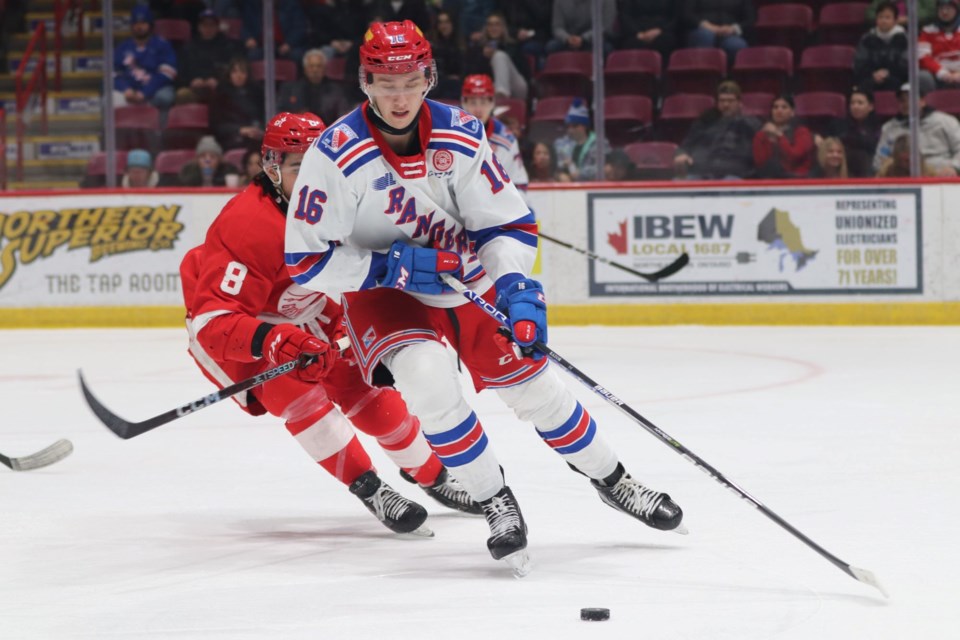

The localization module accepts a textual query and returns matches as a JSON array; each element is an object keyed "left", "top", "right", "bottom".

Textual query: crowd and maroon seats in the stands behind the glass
[{"left": 82, "top": 0, "right": 960, "bottom": 185}]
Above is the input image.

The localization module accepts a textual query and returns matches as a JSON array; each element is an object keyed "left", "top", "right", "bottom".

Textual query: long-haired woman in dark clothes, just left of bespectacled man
[{"left": 211, "top": 57, "right": 264, "bottom": 149}]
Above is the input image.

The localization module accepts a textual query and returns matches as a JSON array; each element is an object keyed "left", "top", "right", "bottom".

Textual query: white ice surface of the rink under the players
[{"left": 0, "top": 327, "right": 960, "bottom": 640}]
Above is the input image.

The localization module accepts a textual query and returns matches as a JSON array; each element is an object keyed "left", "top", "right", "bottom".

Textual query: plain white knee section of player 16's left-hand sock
[{"left": 385, "top": 341, "right": 469, "bottom": 431}]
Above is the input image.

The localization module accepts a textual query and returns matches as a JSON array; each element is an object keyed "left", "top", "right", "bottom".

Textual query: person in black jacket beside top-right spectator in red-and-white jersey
[{"left": 853, "top": 0, "right": 908, "bottom": 91}]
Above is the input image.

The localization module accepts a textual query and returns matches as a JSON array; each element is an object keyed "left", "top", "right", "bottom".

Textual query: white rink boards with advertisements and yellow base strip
[{"left": 0, "top": 180, "right": 960, "bottom": 328}]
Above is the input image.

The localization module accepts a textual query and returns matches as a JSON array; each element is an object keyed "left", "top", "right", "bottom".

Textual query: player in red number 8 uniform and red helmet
[{"left": 180, "top": 113, "right": 479, "bottom": 533}]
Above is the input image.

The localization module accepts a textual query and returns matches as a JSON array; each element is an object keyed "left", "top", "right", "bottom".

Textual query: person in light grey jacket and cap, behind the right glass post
[{"left": 873, "top": 84, "right": 960, "bottom": 177}]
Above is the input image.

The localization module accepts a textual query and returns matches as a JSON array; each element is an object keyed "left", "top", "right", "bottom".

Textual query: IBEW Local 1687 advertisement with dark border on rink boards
[{"left": 587, "top": 188, "right": 923, "bottom": 296}]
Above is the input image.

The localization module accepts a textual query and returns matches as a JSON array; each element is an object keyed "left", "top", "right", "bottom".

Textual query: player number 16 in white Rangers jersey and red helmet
[{"left": 284, "top": 21, "right": 683, "bottom": 575}]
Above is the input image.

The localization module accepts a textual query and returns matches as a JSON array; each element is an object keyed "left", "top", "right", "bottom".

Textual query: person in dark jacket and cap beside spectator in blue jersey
[{"left": 177, "top": 10, "right": 243, "bottom": 104}]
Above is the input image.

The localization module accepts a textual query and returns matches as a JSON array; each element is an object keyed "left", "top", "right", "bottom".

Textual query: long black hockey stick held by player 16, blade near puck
[{"left": 441, "top": 274, "right": 889, "bottom": 597}]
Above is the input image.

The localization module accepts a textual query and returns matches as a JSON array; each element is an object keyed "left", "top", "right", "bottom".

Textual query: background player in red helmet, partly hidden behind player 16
[{"left": 460, "top": 73, "right": 530, "bottom": 204}]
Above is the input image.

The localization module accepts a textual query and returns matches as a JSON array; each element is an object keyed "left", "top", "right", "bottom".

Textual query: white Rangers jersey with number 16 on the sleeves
[{"left": 284, "top": 100, "right": 537, "bottom": 307}]
